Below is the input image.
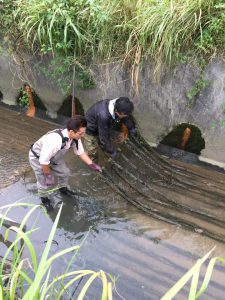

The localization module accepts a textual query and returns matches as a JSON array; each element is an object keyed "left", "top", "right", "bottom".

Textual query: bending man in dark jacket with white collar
[{"left": 84, "top": 97, "right": 136, "bottom": 161}]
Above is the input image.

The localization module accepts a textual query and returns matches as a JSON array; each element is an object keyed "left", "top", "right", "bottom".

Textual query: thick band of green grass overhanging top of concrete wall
[{"left": 0, "top": 0, "right": 225, "bottom": 83}]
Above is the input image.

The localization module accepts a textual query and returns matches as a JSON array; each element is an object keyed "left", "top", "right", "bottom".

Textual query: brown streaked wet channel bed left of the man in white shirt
[{"left": 0, "top": 107, "right": 57, "bottom": 189}]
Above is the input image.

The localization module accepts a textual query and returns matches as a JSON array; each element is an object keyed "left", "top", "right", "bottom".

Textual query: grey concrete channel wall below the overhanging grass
[{"left": 0, "top": 47, "right": 225, "bottom": 167}]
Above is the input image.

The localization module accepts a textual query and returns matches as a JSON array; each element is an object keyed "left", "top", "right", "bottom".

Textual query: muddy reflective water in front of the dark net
[{"left": 0, "top": 155, "right": 225, "bottom": 300}]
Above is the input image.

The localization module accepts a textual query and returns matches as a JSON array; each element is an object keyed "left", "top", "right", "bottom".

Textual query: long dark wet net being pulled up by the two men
[{"left": 101, "top": 135, "right": 225, "bottom": 241}]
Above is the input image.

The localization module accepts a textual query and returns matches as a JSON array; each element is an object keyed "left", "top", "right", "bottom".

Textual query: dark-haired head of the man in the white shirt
[{"left": 67, "top": 115, "right": 87, "bottom": 140}]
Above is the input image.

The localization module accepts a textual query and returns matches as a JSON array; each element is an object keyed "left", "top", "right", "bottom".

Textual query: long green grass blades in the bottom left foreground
[{"left": 0, "top": 203, "right": 114, "bottom": 300}]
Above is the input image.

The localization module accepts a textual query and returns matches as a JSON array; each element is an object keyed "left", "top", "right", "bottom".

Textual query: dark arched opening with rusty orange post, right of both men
[{"left": 160, "top": 123, "right": 205, "bottom": 155}]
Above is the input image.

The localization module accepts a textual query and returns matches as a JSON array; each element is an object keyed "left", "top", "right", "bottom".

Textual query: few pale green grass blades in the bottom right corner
[{"left": 161, "top": 247, "right": 225, "bottom": 300}]
